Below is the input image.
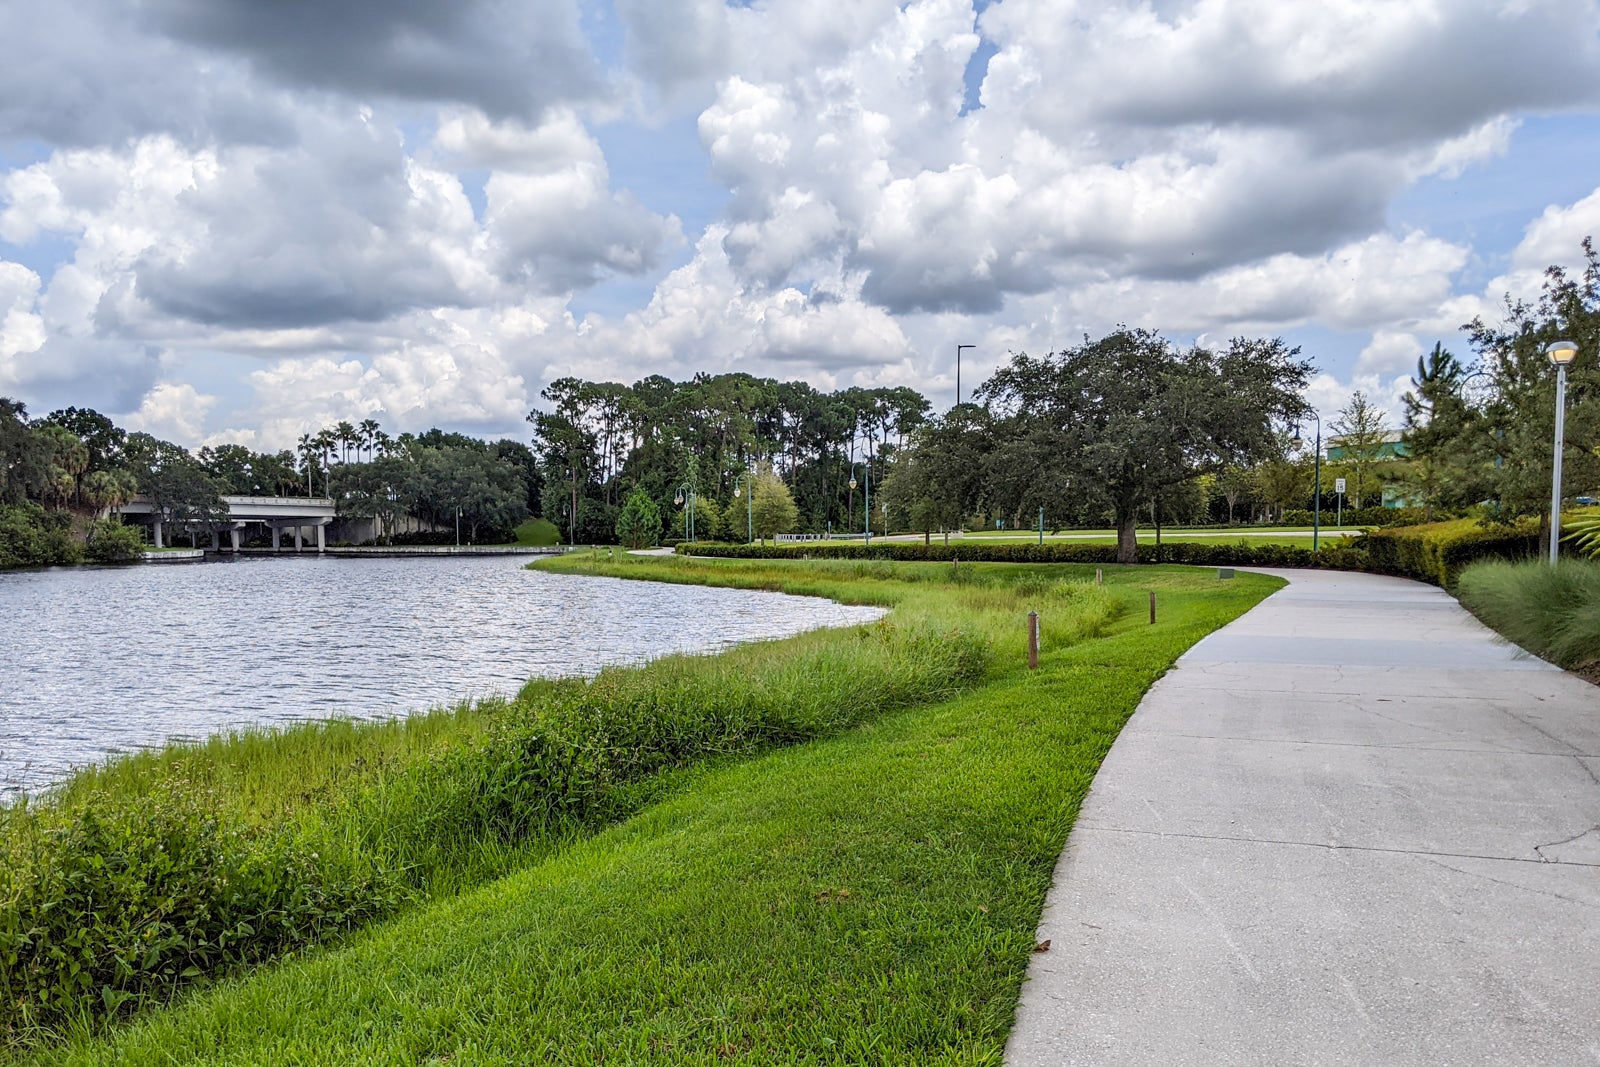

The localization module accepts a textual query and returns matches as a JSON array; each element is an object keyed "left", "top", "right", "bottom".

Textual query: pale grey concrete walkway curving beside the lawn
[{"left": 1006, "top": 571, "right": 1600, "bottom": 1067}]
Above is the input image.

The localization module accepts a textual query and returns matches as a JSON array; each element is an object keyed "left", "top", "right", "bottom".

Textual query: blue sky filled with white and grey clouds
[{"left": 0, "top": 0, "right": 1600, "bottom": 448}]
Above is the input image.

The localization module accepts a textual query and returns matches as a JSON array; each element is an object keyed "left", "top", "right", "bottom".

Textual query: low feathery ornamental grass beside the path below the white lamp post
[{"left": 1456, "top": 560, "right": 1600, "bottom": 669}]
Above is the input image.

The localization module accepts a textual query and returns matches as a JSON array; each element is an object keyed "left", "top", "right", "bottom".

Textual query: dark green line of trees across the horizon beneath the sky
[{"left": 0, "top": 242, "right": 1600, "bottom": 555}]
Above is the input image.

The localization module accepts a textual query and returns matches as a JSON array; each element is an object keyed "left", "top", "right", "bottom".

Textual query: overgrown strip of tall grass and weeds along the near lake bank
[{"left": 0, "top": 622, "right": 987, "bottom": 1045}]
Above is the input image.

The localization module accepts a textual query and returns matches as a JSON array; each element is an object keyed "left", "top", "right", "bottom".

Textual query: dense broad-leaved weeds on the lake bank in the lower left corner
[{"left": 0, "top": 793, "right": 400, "bottom": 1035}]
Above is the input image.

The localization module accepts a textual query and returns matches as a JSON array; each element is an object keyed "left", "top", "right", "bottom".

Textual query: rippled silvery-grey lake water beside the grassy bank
[{"left": 0, "top": 555, "right": 882, "bottom": 795}]
